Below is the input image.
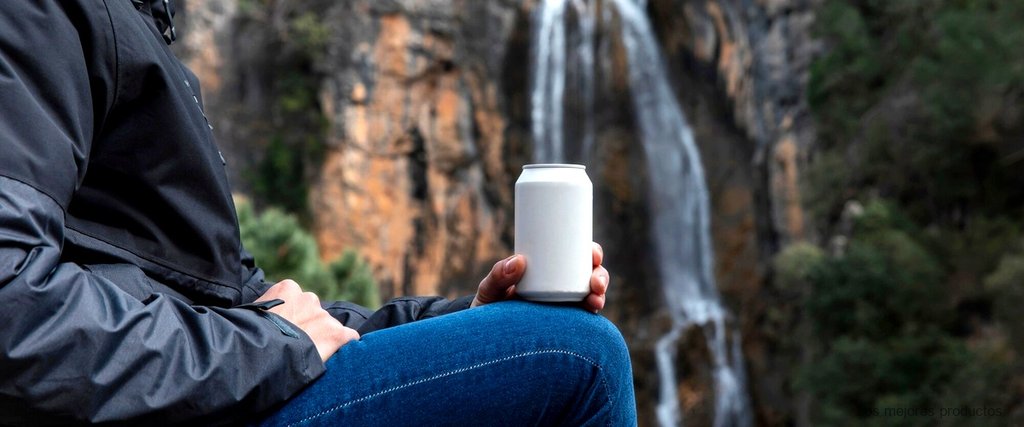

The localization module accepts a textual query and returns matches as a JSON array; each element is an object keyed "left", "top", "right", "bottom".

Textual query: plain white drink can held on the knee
[{"left": 515, "top": 164, "right": 594, "bottom": 301}]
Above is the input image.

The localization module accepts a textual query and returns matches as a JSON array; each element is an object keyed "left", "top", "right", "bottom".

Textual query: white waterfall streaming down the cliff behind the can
[{"left": 530, "top": 0, "right": 752, "bottom": 427}]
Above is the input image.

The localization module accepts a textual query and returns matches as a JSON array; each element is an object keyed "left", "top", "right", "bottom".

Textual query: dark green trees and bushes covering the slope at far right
[{"left": 775, "top": 0, "right": 1024, "bottom": 425}]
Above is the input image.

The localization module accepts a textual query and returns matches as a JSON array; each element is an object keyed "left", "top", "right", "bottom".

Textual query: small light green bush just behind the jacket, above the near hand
[{"left": 237, "top": 197, "right": 380, "bottom": 307}]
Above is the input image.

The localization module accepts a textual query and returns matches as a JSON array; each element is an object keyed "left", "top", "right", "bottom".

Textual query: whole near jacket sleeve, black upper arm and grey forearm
[{"left": 0, "top": 0, "right": 324, "bottom": 425}]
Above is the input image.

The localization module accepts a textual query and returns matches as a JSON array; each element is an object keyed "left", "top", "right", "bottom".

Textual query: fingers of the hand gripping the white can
[{"left": 472, "top": 243, "right": 610, "bottom": 312}]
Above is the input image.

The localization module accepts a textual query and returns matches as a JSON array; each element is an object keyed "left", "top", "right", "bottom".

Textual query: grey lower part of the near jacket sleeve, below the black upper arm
[{"left": 0, "top": 176, "right": 324, "bottom": 425}]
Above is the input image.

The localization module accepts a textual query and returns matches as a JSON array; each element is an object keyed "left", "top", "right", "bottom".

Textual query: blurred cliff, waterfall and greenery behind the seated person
[{"left": 173, "top": 0, "right": 1024, "bottom": 426}]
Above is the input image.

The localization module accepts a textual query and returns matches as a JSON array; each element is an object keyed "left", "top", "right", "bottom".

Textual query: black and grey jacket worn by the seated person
[{"left": 0, "top": 0, "right": 469, "bottom": 425}]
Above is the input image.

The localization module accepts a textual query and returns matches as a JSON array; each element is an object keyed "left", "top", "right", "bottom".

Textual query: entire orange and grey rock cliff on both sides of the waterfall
[{"left": 175, "top": 0, "right": 819, "bottom": 426}]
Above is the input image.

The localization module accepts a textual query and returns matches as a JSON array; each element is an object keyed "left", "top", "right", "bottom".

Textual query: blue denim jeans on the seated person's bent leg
[{"left": 261, "top": 301, "right": 636, "bottom": 426}]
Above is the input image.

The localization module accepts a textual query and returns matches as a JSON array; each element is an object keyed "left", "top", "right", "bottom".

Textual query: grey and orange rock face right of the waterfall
[{"left": 648, "top": 0, "right": 821, "bottom": 425}]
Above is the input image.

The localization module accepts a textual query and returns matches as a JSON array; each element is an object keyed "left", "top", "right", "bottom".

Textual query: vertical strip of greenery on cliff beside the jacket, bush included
[{"left": 230, "top": 0, "right": 380, "bottom": 307}]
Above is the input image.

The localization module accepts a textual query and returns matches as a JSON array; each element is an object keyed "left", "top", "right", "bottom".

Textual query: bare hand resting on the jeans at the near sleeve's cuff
[{"left": 256, "top": 281, "right": 359, "bottom": 361}]
